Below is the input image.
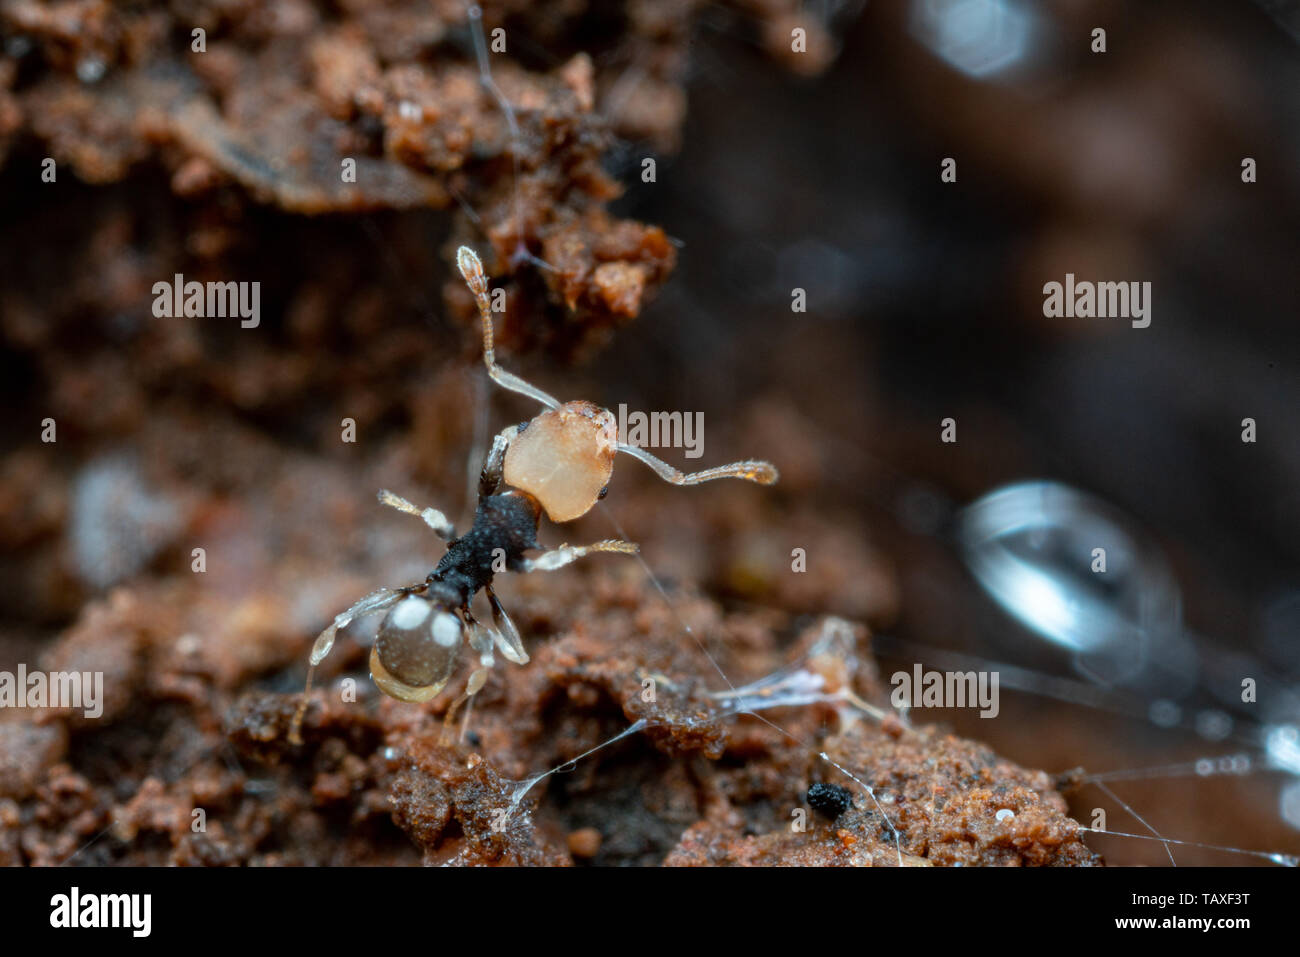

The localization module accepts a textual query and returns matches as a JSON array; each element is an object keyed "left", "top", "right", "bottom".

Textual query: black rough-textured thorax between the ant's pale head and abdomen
[{"left": 428, "top": 492, "right": 542, "bottom": 609}]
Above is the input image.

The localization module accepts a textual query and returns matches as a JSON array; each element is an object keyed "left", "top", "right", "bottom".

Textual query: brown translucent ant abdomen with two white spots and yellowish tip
[{"left": 371, "top": 596, "right": 463, "bottom": 702}]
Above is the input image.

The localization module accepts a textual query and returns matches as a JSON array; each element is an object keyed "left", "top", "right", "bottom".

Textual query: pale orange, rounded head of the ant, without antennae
[{"left": 504, "top": 399, "right": 619, "bottom": 521}]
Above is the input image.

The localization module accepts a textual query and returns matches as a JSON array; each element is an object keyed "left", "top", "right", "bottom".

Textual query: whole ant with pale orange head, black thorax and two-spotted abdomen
[{"left": 289, "top": 246, "right": 777, "bottom": 745}]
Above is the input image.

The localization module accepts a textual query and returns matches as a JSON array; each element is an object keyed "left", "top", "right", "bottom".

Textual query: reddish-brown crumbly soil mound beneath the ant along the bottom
[{"left": 0, "top": 566, "right": 1100, "bottom": 866}]
